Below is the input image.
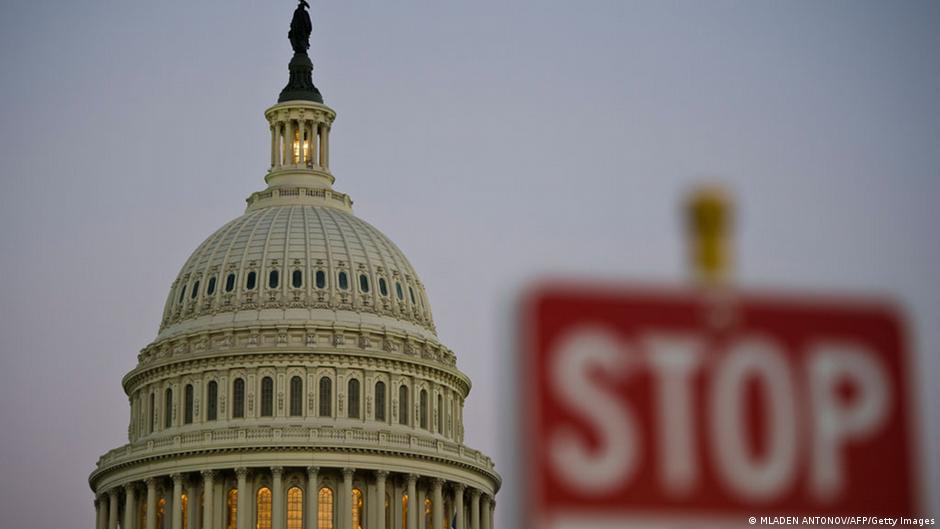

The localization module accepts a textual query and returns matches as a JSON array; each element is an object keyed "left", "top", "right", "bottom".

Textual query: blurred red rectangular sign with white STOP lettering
[{"left": 522, "top": 285, "right": 920, "bottom": 529}]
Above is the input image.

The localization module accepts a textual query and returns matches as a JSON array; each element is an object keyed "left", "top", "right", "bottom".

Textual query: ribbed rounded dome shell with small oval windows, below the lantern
[{"left": 158, "top": 200, "right": 436, "bottom": 340}]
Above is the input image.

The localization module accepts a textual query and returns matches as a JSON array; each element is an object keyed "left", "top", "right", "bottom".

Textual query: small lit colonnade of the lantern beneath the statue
[{"left": 271, "top": 118, "right": 330, "bottom": 171}]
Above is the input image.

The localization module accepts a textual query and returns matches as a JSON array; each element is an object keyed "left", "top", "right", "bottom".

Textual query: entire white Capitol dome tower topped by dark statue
[{"left": 89, "top": 2, "right": 500, "bottom": 529}]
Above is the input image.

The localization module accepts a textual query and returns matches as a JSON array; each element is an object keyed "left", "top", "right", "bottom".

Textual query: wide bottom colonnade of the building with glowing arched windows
[{"left": 95, "top": 466, "right": 496, "bottom": 529}]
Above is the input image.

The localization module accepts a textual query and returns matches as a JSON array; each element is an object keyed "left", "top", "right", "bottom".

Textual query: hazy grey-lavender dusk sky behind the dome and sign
[{"left": 0, "top": 0, "right": 940, "bottom": 528}]
